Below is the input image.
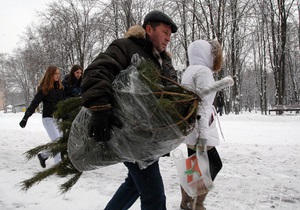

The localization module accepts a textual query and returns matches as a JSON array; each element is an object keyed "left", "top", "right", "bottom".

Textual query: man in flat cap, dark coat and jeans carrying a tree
[{"left": 81, "top": 11, "right": 177, "bottom": 210}]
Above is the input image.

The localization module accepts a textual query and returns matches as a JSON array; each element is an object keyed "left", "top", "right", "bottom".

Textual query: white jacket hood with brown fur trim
[{"left": 188, "top": 40, "right": 222, "bottom": 71}]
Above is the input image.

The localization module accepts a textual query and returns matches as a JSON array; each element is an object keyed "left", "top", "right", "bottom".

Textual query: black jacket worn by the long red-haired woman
[{"left": 25, "top": 83, "right": 65, "bottom": 119}]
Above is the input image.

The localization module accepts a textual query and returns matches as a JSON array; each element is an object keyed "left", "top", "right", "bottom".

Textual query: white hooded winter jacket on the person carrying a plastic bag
[{"left": 181, "top": 40, "right": 220, "bottom": 146}]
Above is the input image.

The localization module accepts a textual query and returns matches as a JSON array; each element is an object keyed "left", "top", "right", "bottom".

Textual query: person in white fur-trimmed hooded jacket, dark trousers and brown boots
[{"left": 180, "top": 40, "right": 222, "bottom": 210}]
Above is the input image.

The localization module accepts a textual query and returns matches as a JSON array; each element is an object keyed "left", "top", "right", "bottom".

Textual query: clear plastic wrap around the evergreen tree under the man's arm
[{"left": 68, "top": 54, "right": 200, "bottom": 171}]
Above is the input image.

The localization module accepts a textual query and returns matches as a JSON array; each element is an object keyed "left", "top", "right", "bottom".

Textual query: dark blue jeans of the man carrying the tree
[{"left": 105, "top": 161, "right": 166, "bottom": 210}]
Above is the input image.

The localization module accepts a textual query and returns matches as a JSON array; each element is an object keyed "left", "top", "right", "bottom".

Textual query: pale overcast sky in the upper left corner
[{"left": 0, "top": 0, "right": 54, "bottom": 53}]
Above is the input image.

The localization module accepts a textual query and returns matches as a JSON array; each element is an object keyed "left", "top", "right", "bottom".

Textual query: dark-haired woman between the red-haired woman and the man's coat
[{"left": 62, "top": 65, "right": 83, "bottom": 98}]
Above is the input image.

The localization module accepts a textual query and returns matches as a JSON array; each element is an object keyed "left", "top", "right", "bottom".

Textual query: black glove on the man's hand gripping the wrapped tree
[{"left": 90, "top": 109, "right": 122, "bottom": 142}]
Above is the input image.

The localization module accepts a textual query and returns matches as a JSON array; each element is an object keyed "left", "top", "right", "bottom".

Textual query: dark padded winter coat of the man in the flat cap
[{"left": 81, "top": 27, "right": 177, "bottom": 107}]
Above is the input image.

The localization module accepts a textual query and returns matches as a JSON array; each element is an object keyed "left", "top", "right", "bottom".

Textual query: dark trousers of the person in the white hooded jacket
[{"left": 188, "top": 147, "right": 223, "bottom": 181}]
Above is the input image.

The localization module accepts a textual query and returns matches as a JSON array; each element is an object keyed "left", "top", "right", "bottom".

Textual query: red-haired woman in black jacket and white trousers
[{"left": 19, "top": 65, "right": 65, "bottom": 168}]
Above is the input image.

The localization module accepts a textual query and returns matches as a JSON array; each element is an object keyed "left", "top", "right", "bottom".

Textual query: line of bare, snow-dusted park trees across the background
[{"left": 0, "top": 0, "right": 300, "bottom": 114}]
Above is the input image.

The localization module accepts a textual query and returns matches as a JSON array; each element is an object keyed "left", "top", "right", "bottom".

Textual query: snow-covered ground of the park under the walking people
[{"left": 0, "top": 112, "right": 300, "bottom": 210}]
